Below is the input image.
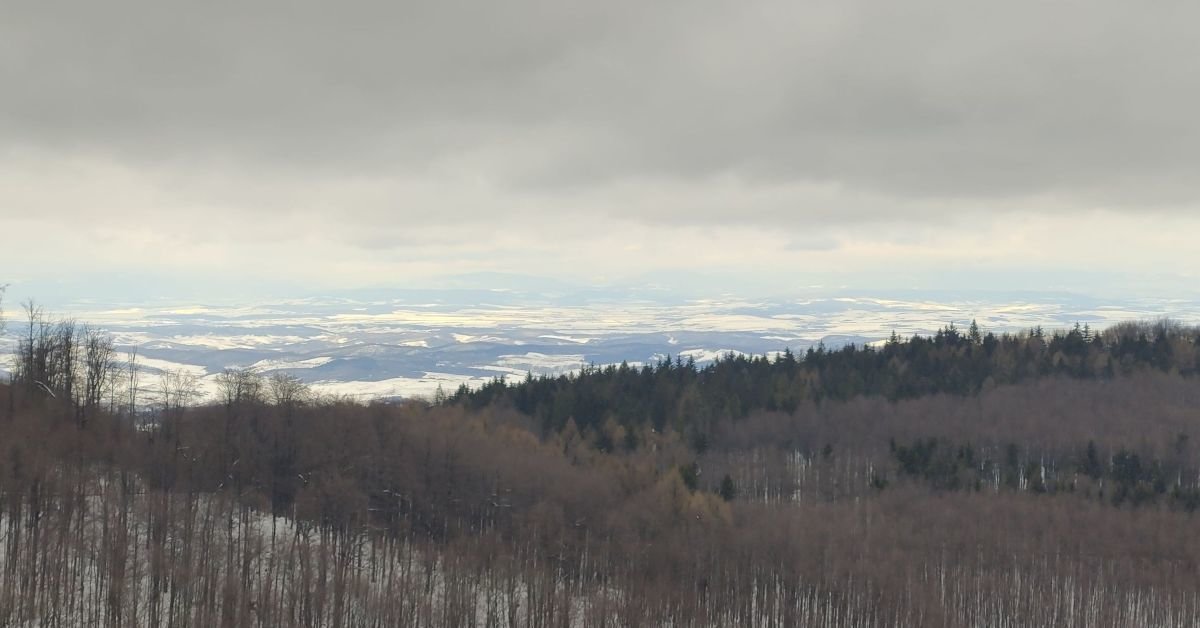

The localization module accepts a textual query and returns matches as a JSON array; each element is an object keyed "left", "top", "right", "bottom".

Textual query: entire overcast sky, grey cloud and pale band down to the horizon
[{"left": 0, "top": 0, "right": 1200, "bottom": 297}]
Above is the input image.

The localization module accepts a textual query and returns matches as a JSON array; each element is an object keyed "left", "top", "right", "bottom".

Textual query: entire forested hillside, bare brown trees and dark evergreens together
[{"left": 0, "top": 296, "right": 1200, "bottom": 627}]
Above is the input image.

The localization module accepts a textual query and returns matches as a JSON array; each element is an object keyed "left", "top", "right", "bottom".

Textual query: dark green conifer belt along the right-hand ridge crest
[{"left": 450, "top": 321, "right": 1200, "bottom": 449}]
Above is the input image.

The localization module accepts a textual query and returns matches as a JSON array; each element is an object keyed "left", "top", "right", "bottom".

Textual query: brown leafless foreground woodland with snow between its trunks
[{"left": 7, "top": 377, "right": 1200, "bottom": 627}]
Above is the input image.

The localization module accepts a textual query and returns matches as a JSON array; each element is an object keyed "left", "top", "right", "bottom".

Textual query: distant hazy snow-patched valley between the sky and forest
[{"left": 0, "top": 283, "right": 1200, "bottom": 402}]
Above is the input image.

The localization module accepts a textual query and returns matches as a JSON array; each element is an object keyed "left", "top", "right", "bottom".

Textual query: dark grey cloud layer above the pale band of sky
[{"left": 0, "top": 0, "right": 1200, "bottom": 222}]
